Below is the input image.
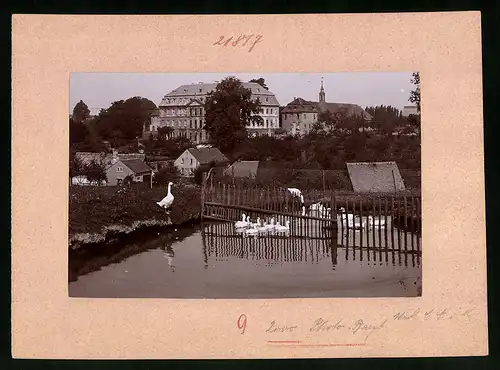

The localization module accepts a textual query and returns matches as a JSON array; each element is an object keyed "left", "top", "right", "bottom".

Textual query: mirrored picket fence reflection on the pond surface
[{"left": 202, "top": 223, "right": 421, "bottom": 267}]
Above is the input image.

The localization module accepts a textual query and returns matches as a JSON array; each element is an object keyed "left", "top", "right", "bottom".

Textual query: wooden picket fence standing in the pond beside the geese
[{"left": 202, "top": 180, "right": 421, "bottom": 254}]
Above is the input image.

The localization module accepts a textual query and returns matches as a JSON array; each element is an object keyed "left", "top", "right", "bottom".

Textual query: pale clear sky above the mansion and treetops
[{"left": 69, "top": 72, "right": 414, "bottom": 113}]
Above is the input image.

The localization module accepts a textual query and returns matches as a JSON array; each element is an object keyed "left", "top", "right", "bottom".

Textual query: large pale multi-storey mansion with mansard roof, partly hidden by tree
[{"left": 145, "top": 82, "right": 279, "bottom": 144}]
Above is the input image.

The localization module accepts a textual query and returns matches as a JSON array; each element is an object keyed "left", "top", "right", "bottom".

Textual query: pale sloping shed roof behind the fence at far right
[{"left": 346, "top": 162, "right": 405, "bottom": 193}]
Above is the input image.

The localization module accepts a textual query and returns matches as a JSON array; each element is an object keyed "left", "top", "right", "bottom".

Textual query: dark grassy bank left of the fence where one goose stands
[{"left": 69, "top": 184, "right": 200, "bottom": 249}]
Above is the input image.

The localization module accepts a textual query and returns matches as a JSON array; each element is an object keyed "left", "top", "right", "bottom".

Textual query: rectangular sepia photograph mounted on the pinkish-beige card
[{"left": 68, "top": 71, "right": 422, "bottom": 299}]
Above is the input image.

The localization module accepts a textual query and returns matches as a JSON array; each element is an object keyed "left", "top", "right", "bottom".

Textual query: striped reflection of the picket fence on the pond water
[{"left": 202, "top": 223, "right": 421, "bottom": 270}]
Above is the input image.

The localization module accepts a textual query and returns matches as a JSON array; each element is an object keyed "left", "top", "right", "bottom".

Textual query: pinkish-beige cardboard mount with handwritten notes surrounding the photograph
[{"left": 12, "top": 12, "right": 488, "bottom": 358}]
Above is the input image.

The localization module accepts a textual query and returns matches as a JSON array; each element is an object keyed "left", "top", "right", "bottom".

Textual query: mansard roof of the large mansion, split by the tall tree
[{"left": 159, "top": 82, "right": 279, "bottom": 106}]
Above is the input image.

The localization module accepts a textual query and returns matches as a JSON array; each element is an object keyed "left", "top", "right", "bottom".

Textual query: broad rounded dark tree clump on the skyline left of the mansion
[{"left": 95, "top": 96, "right": 156, "bottom": 141}]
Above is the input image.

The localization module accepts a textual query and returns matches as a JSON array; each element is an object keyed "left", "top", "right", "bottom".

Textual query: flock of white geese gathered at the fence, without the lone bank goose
[{"left": 234, "top": 188, "right": 385, "bottom": 237}]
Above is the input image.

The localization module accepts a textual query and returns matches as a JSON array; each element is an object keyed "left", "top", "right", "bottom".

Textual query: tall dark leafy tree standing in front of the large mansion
[{"left": 204, "top": 77, "right": 263, "bottom": 153}]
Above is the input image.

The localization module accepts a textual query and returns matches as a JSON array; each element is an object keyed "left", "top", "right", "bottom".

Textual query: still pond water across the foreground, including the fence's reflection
[{"left": 69, "top": 223, "right": 421, "bottom": 299}]
